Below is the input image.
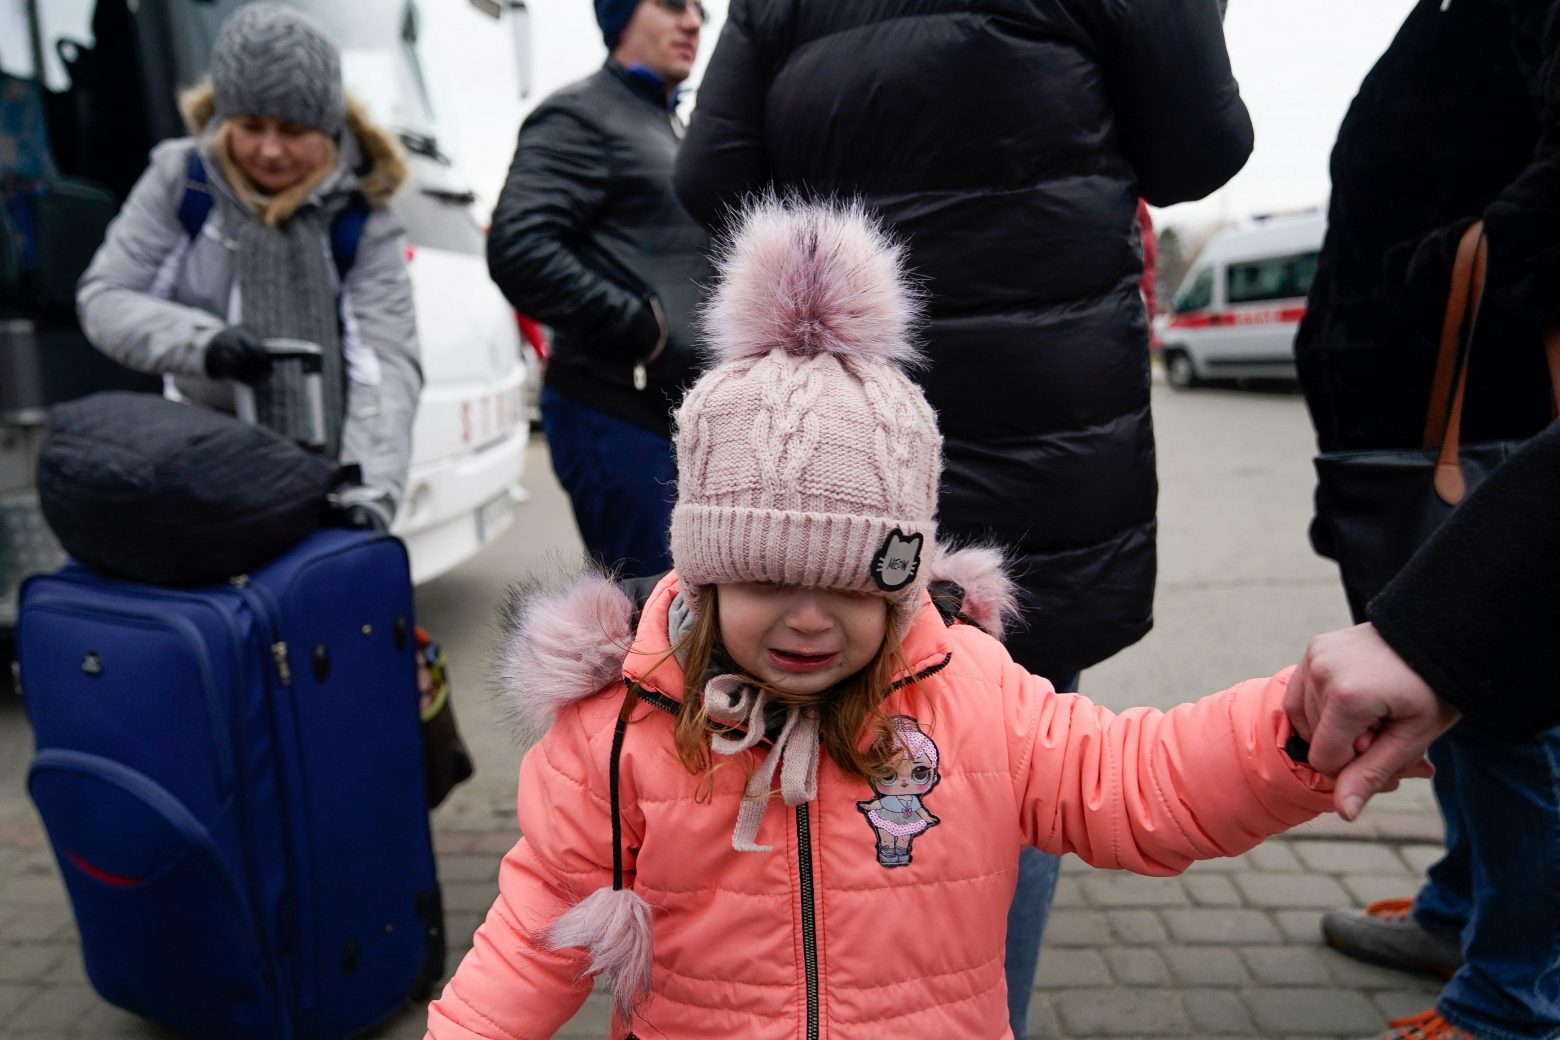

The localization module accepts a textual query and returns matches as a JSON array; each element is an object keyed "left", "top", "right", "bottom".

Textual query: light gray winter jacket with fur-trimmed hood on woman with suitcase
[{"left": 76, "top": 92, "right": 423, "bottom": 504}]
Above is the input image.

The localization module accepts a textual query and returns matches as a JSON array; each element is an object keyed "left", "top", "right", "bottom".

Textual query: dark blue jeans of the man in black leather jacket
[{"left": 541, "top": 387, "right": 677, "bottom": 578}]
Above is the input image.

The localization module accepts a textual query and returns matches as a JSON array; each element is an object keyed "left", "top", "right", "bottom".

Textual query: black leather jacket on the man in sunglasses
[{"left": 488, "top": 59, "right": 708, "bottom": 435}]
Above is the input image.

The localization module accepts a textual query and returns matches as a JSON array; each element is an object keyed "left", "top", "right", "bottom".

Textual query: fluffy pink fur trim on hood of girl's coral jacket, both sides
[{"left": 496, "top": 546, "right": 1019, "bottom": 744}]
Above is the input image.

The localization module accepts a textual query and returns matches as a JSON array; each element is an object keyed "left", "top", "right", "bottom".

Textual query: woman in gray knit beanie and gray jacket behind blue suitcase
[{"left": 76, "top": 3, "right": 423, "bottom": 527}]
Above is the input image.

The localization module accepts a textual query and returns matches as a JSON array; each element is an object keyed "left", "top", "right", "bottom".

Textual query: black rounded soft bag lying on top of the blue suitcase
[{"left": 37, "top": 391, "right": 342, "bottom": 586}]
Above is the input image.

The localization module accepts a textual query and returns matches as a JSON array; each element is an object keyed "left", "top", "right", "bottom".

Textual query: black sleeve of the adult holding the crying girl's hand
[{"left": 1367, "top": 424, "right": 1560, "bottom": 739}]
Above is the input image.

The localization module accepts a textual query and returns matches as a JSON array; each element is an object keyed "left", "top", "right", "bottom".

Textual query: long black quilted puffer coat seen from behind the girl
[{"left": 677, "top": 0, "right": 1251, "bottom": 678}]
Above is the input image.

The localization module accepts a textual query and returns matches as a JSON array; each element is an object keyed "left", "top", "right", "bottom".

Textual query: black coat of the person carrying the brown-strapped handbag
[{"left": 1295, "top": 0, "right": 1560, "bottom": 455}]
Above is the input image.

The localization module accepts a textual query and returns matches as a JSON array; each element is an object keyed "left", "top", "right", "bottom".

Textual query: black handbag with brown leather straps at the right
[{"left": 1314, "top": 221, "right": 1560, "bottom": 621}]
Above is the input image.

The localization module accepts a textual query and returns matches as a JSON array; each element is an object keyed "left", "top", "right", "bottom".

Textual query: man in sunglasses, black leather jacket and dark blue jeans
[{"left": 488, "top": 0, "right": 707, "bottom": 577}]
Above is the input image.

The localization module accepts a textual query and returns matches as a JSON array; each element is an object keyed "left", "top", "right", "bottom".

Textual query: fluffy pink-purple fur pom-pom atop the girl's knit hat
[{"left": 700, "top": 193, "right": 920, "bottom": 366}]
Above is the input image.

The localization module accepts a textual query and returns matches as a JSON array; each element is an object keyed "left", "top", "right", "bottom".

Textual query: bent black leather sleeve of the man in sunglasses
[{"left": 487, "top": 108, "right": 657, "bottom": 360}]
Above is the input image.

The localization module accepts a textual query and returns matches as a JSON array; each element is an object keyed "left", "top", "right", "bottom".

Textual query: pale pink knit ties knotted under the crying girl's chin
[{"left": 666, "top": 594, "right": 819, "bottom": 853}]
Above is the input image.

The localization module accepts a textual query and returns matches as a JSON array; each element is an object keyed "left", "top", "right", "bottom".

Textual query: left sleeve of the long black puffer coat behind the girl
[{"left": 677, "top": 0, "right": 772, "bottom": 232}]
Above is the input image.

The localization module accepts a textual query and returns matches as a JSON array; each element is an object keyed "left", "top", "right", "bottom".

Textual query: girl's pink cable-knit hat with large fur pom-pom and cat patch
[{"left": 671, "top": 196, "right": 942, "bottom": 627}]
